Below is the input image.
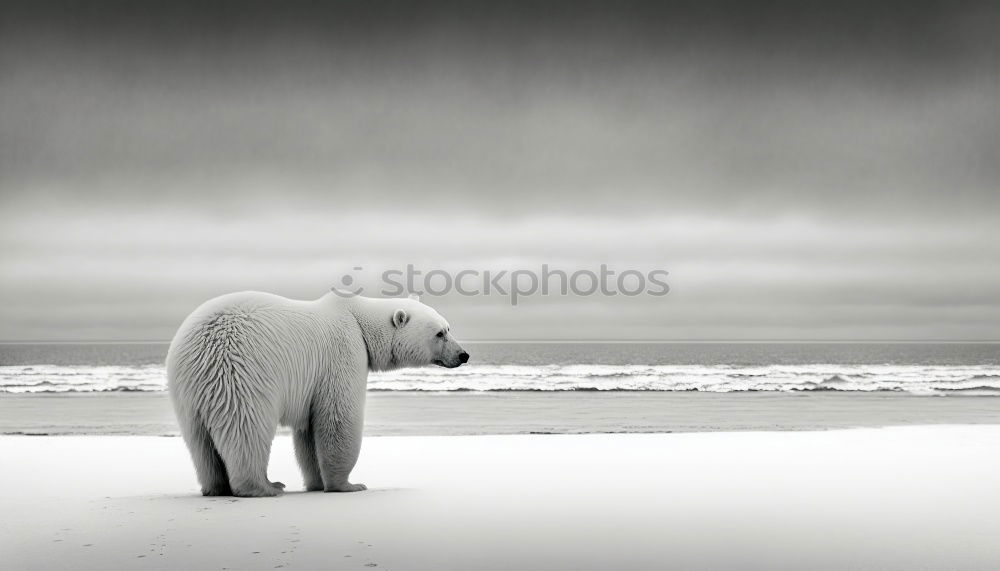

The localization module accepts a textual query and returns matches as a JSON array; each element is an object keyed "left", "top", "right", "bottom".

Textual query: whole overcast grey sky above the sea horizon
[{"left": 0, "top": 1, "right": 1000, "bottom": 340}]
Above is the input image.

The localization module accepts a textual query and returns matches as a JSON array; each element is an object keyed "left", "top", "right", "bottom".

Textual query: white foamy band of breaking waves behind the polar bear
[{"left": 0, "top": 364, "right": 1000, "bottom": 395}]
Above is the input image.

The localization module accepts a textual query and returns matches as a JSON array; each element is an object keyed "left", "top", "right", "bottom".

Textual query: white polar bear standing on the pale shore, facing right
[{"left": 167, "top": 291, "right": 469, "bottom": 497}]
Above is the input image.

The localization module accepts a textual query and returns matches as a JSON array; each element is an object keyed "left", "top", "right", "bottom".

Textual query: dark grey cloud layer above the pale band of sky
[{"left": 0, "top": 3, "right": 1000, "bottom": 213}]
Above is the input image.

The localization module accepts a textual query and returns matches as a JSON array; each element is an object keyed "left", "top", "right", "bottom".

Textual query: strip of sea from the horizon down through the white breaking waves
[{"left": 0, "top": 343, "right": 1000, "bottom": 396}]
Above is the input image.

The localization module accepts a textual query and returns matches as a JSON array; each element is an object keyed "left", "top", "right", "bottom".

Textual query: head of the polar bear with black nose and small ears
[{"left": 391, "top": 299, "right": 469, "bottom": 369}]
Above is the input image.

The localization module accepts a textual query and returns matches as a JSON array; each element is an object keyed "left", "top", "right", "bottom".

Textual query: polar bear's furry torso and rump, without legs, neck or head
[{"left": 167, "top": 292, "right": 352, "bottom": 432}]
